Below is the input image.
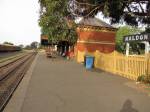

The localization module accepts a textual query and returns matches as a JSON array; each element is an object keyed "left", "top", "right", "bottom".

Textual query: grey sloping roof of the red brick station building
[{"left": 79, "top": 18, "right": 114, "bottom": 28}]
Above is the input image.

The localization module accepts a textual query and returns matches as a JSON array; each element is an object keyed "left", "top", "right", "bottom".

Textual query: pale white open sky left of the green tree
[{"left": 0, "top": 0, "right": 40, "bottom": 45}]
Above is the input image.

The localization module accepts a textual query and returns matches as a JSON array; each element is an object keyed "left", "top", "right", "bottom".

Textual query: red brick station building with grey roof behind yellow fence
[{"left": 75, "top": 18, "right": 117, "bottom": 62}]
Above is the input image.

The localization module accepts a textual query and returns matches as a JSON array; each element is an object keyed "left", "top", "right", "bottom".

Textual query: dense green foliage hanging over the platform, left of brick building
[{"left": 39, "top": 0, "right": 76, "bottom": 42}]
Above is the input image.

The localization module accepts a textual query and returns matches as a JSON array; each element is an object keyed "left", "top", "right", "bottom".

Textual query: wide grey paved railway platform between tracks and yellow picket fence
[{"left": 4, "top": 52, "right": 150, "bottom": 112}]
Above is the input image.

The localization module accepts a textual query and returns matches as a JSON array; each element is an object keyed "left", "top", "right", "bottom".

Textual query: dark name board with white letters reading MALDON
[{"left": 124, "top": 34, "right": 150, "bottom": 42}]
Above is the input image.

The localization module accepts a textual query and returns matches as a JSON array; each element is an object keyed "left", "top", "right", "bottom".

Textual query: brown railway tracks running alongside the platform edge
[{"left": 0, "top": 52, "right": 37, "bottom": 112}]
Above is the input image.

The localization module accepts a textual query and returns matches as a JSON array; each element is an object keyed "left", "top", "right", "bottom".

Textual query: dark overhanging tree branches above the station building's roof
[{"left": 68, "top": 0, "right": 150, "bottom": 26}]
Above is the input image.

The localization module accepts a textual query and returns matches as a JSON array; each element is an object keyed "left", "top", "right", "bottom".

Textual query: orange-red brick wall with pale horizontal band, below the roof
[{"left": 76, "top": 30, "right": 116, "bottom": 53}]
